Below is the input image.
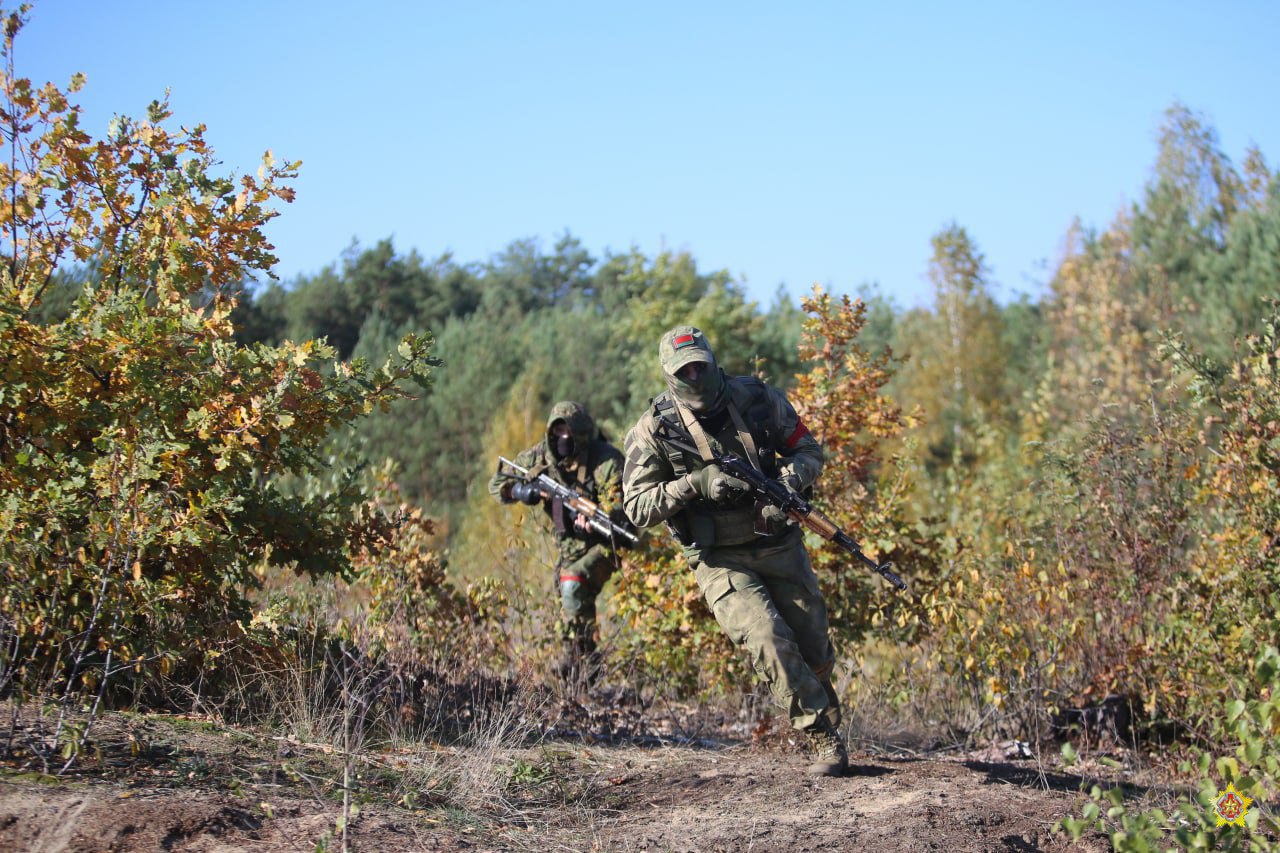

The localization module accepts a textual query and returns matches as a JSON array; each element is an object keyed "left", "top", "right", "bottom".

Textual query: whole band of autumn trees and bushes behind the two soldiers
[{"left": 0, "top": 3, "right": 1280, "bottom": 833}]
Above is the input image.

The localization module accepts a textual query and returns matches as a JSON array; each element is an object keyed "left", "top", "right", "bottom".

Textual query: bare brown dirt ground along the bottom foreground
[{"left": 0, "top": 745, "right": 1107, "bottom": 853}]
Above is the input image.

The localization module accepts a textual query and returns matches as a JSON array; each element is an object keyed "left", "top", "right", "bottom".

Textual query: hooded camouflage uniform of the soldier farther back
[{"left": 489, "top": 401, "right": 630, "bottom": 670}]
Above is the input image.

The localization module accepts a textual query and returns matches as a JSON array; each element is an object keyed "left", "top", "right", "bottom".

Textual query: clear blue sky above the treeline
[{"left": 17, "top": 0, "right": 1280, "bottom": 307}]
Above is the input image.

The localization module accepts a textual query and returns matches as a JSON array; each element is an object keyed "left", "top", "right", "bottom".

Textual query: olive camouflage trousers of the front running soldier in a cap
[{"left": 694, "top": 530, "right": 840, "bottom": 729}]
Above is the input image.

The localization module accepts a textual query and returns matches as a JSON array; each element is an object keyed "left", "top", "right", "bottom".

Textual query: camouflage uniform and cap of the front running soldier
[{"left": 623, "top": 327, "right": 847, "bottom": 772}]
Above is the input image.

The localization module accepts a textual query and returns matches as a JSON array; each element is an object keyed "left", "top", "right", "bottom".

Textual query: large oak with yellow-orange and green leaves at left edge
[{"left": 0, "top": 3, "right": 433, "bottom": 732}]
